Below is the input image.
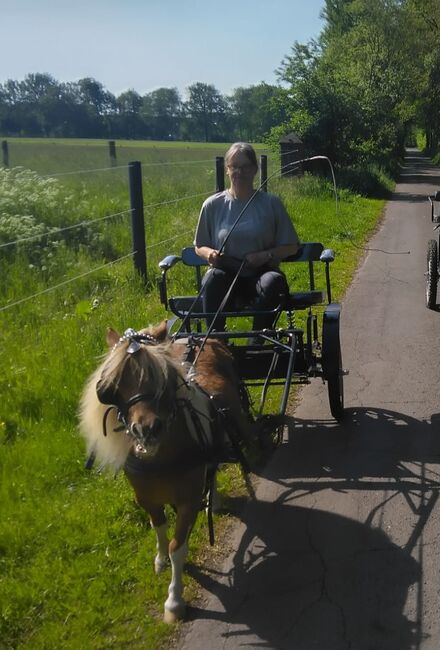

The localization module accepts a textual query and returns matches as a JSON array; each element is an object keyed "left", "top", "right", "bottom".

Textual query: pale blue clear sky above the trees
[{"left": 0, "top": 0, "right": 324, "bottom": 97}]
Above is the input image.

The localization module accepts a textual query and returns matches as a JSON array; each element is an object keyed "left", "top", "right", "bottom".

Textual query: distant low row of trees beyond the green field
[{"left": 0, "top": 73, "right": 286, "bottom": 142}]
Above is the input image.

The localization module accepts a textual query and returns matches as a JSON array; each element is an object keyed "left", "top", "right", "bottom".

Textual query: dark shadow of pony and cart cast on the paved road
[{"left": 183, "top": 408, "right": 440, "bottom": 650}]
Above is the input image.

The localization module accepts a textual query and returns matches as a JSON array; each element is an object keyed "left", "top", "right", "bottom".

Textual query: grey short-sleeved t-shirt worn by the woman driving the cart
[{"left": 194, "top": 190, "right": 299, "bottom": 259}]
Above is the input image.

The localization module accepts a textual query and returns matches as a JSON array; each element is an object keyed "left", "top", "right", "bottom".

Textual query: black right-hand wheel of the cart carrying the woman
[{"left": 322, "top": 303, "right": 344, "bottom": 420}]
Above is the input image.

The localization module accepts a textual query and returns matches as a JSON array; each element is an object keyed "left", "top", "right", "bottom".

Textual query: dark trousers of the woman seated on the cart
[{"left": 202, "top": 268, "right": 289, "bottom": 331}]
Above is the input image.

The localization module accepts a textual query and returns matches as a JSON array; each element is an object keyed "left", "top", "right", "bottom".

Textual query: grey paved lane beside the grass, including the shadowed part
[{"left": 179, "top": 151, "right": 440, "bottom": 650}]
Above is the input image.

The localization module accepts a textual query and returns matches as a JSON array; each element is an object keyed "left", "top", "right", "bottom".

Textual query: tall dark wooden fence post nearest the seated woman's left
[{"left": 128, "top": 161, "right": 147, "bottom": 282}]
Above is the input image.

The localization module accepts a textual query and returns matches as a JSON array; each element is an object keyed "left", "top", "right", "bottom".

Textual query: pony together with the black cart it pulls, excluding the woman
[{"left": 80, "top": 237, "right": 344, "bottom": 623}]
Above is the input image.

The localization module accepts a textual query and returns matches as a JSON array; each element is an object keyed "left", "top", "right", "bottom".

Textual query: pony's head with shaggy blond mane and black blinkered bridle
[{"left": 81, "top": 322, "right": 184, "bottom": 467}]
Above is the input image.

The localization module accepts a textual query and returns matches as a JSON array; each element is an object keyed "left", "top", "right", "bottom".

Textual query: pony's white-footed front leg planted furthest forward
[{"left": 164, "top": 508, "right": 198, "bottom": 623}]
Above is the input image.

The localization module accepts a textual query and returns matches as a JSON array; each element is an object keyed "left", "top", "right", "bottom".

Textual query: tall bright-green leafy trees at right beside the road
[{"left": 273, "top": 0, "right": 440, "bottom": 170}]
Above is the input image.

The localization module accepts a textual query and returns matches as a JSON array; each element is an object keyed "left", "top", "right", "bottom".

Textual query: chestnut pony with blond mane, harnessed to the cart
[{"left": 80, "top": 321, "right": 258, "bottom": 623}]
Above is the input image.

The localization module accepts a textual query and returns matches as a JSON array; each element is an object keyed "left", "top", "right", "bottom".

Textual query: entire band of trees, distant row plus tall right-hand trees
[{"left": 0, "top": 0, "right": 440, "bottom": 177}]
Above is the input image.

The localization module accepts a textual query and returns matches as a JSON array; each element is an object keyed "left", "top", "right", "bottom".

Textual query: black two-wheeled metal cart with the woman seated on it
[{"left": 159, "top": 242, "right": 344, "bottom": 420}]
